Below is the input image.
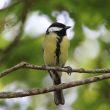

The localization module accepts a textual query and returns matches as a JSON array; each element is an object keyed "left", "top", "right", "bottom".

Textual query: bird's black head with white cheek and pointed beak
[{"left": 46, "top": 22, "right": 70, "bottom": 37}]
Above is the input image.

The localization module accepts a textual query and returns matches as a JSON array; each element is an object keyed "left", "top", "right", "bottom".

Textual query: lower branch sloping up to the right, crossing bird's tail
[{"left": 0, "top": 73, "right": 110, "bottom": 98}]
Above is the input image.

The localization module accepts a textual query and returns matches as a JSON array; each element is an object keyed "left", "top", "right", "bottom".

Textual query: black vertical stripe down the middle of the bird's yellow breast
[{"left": 55, "top": 37, "right": 62, "bottom": 65}]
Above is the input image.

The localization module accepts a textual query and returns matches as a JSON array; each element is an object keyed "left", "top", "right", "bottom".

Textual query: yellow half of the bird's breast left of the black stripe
[{"left": 43, "top": 33, "right": 57, "bottom": 66}]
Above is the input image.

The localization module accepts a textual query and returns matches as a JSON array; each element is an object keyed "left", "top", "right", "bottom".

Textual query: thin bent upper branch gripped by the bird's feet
[{"left": 0, "top": 62, "right": 110, "bottom": 78}]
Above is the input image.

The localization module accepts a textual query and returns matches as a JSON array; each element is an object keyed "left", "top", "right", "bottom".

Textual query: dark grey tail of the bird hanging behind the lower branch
[{"left": 49, "top": 71, "right": 65, "bottom": 105}]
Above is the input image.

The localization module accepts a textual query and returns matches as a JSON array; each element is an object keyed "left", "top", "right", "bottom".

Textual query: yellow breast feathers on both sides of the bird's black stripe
[{"left": 43, "top": 33, "right": 69, "bottom": 66}]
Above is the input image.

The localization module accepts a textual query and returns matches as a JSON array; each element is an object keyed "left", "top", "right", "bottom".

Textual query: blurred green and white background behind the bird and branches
[{"left": 0, "top": 0, "right": 110, "bottom": 110}]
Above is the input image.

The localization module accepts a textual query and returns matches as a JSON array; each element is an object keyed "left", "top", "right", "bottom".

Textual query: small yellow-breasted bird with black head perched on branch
[{"left": 43, "top": 22, "right": 71, "bottom": 105}]
